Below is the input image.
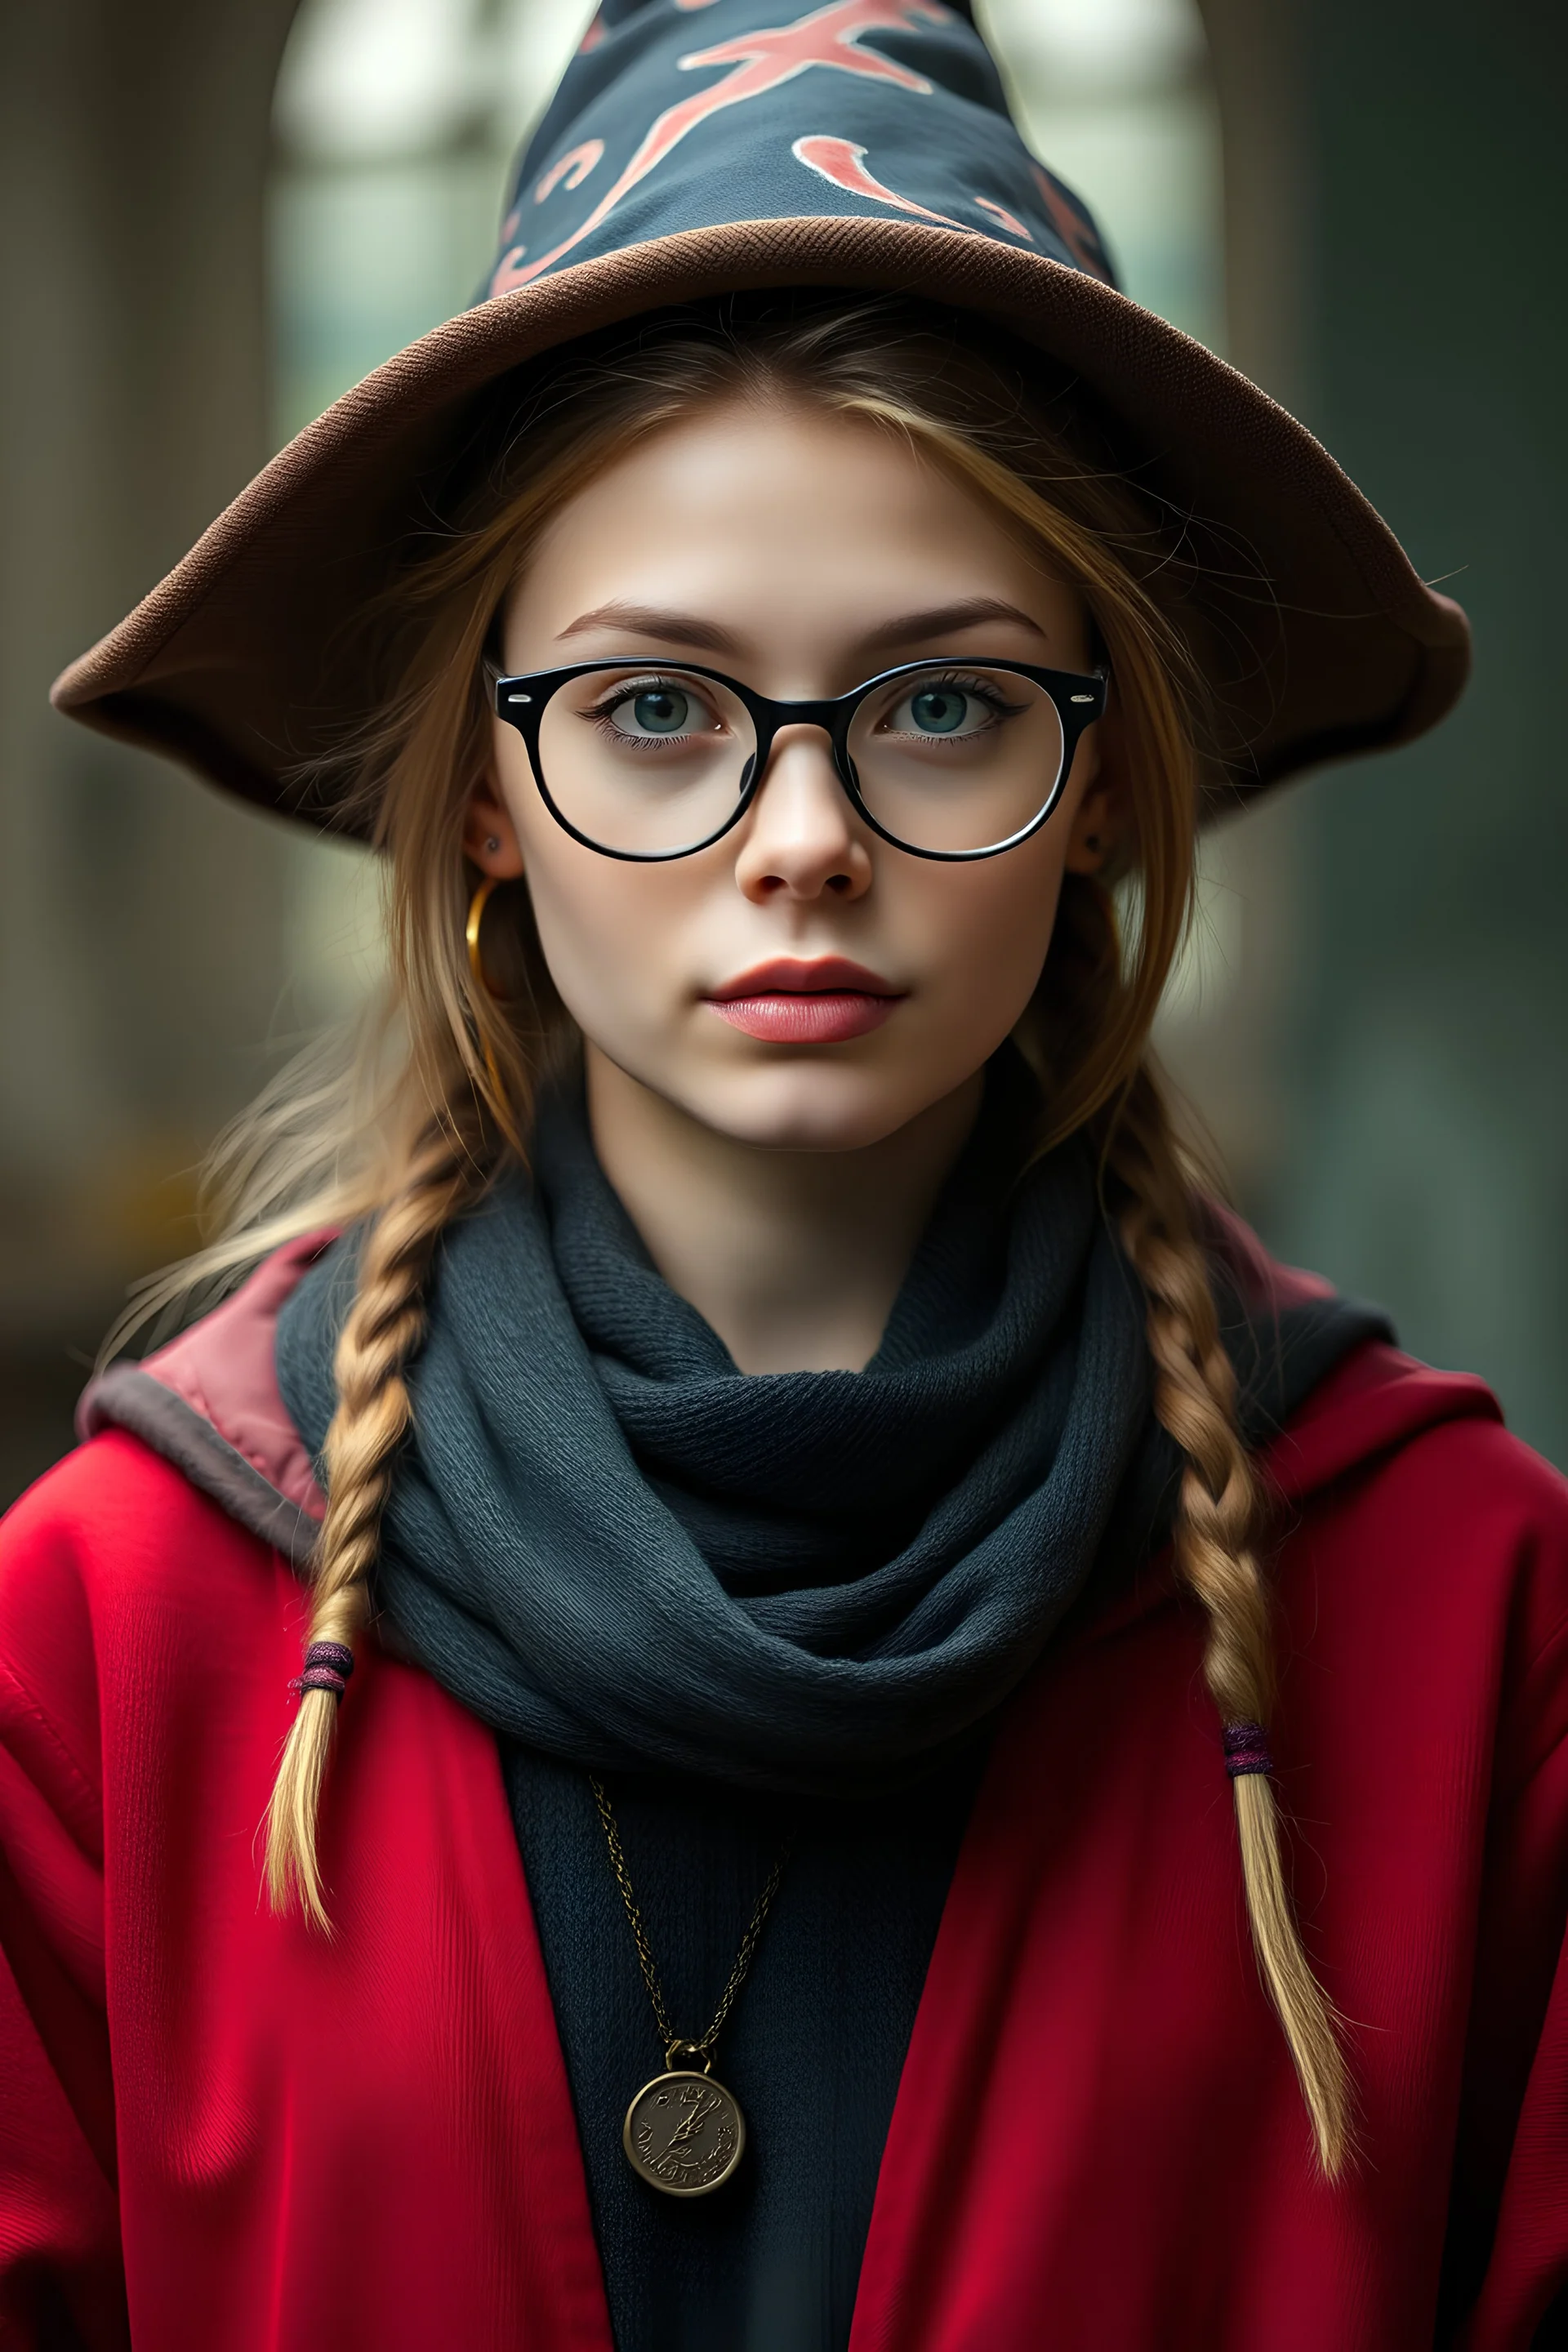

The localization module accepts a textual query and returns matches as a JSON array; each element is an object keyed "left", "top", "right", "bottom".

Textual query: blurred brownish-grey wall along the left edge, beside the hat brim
[{"left": 0, "top": 0, "right": 294, "bottom": 1496}]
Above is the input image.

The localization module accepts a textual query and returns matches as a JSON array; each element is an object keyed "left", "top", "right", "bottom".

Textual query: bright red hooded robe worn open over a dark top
[{"left": 0, "top": 1246, "right": 1568, "bottom": 2352}]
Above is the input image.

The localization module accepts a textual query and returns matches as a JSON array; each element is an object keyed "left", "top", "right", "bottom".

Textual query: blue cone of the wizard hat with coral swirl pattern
[{"left": 487, "top": 0, "right": 1114, "bottom": 294}]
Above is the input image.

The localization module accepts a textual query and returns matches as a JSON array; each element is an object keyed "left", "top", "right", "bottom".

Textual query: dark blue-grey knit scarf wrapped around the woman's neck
[{"left": 278, "top": 1049, "right": 1387, "bottom": 1794}]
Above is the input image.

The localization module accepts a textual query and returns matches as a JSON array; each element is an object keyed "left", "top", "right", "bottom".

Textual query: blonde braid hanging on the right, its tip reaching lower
[{"left": 1105, "top": 1063, "right": 1352, "bottom": 2180}]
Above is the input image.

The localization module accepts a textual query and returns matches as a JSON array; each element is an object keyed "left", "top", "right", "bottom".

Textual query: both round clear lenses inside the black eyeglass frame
[{"left": 538, "top": 663, "right": 1062, "bottom": 856}]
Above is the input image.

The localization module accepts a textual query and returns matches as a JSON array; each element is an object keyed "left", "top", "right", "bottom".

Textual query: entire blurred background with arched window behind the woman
[{"left": 0, "top": 0, "right": 1568, "bottom": 1500}]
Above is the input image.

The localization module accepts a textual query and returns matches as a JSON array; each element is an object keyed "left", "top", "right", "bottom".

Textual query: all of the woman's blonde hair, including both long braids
[{"left": 159, "top": 296, "right": 1352, "bottom": 2176}]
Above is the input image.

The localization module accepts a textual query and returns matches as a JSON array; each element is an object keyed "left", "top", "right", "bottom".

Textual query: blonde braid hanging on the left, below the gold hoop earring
[{"left": 265, "top": 1129, "right": 477, "bottom": 1931}]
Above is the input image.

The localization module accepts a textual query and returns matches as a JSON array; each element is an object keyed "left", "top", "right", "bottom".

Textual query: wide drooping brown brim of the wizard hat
[{"left": 51, "top": 219, "right": 1469, "bottom": 823}]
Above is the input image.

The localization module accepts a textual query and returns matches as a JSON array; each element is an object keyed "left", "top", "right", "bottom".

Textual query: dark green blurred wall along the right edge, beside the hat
[{"left": 1265, "top": 0, "right": 1568, "bottom": 1463}]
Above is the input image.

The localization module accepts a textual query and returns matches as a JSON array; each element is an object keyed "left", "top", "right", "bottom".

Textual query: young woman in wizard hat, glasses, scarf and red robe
[{"left": 0, "top": 0, "right": 1568, "bottom": 2352}]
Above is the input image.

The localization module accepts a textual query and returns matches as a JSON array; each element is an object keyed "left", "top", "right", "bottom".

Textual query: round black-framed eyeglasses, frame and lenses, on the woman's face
[{"left": 496, "top": 661, "right": 1107, "bottom": 863}]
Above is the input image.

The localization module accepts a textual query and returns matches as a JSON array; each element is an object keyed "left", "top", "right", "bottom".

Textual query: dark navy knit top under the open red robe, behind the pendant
[{"left": 503, "top": 1745, "right": 982, "bottom": 2352}]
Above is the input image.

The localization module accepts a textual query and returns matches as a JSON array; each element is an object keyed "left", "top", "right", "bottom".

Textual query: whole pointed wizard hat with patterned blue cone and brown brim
[{"left": 54, "top": 0, "right": 1469, "bottom": 823}]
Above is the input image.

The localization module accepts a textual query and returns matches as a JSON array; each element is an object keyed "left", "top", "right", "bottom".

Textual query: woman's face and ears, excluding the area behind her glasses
[{"left": 466, "top": 400, "right": 1110, "bottom": 1150}]
